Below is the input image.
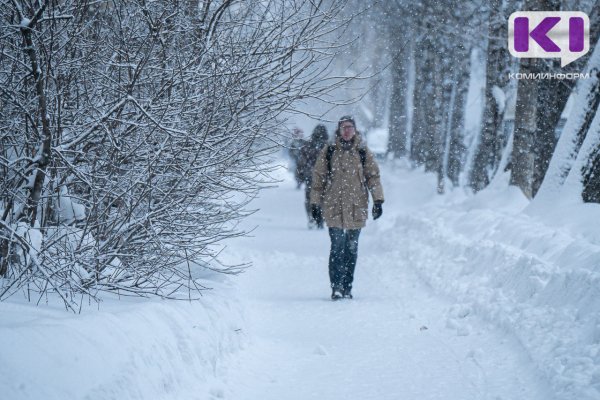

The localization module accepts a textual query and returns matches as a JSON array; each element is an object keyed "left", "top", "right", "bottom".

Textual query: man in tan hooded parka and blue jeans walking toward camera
[{"left": 310, "top": 116, "right": 384, "bottom": 300}]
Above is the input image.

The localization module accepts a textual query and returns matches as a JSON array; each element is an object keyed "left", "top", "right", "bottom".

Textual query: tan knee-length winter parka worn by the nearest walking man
[{"left": 310, "top": 132, "right": 384, "bottom": 229}]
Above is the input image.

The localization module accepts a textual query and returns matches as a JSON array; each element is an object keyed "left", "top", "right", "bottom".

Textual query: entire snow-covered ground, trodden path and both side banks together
[{"left": 0, "top": 160, "right": 600, "bottom": 400}]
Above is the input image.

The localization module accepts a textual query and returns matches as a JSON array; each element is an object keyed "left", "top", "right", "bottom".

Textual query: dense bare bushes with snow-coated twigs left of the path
[{"left": 0, "top": 0, "right": 352, "bottom": 308}]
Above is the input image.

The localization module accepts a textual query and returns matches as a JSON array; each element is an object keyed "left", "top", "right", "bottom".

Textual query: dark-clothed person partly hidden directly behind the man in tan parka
[{"left": 296, "top": 124, "right": 329, "bottom": 229}]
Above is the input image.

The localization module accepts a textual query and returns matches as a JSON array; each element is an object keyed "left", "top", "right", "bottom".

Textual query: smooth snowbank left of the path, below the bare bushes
[{"left": 0, "top": 282, "right": 245, "bottom": 400}]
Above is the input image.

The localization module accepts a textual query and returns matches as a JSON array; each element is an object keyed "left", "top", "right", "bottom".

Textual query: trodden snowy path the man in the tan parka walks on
[{"left": 222, "top": 164, "right": 553, "bottom": 400}]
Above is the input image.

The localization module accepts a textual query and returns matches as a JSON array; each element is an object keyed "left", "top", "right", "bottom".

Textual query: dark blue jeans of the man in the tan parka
[{"left": 329, "top": 228, "right": 360, "bottom": 292}]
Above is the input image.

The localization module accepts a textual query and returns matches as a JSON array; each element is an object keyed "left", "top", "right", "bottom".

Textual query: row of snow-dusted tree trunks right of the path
[{"left": 350, "top": 0, "right": 600, "bottom": 202}]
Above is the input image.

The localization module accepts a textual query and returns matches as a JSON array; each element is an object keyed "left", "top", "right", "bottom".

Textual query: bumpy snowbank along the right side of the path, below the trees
[{"left": 377, "top": 164, "right": 600, "bottom": 400}]
